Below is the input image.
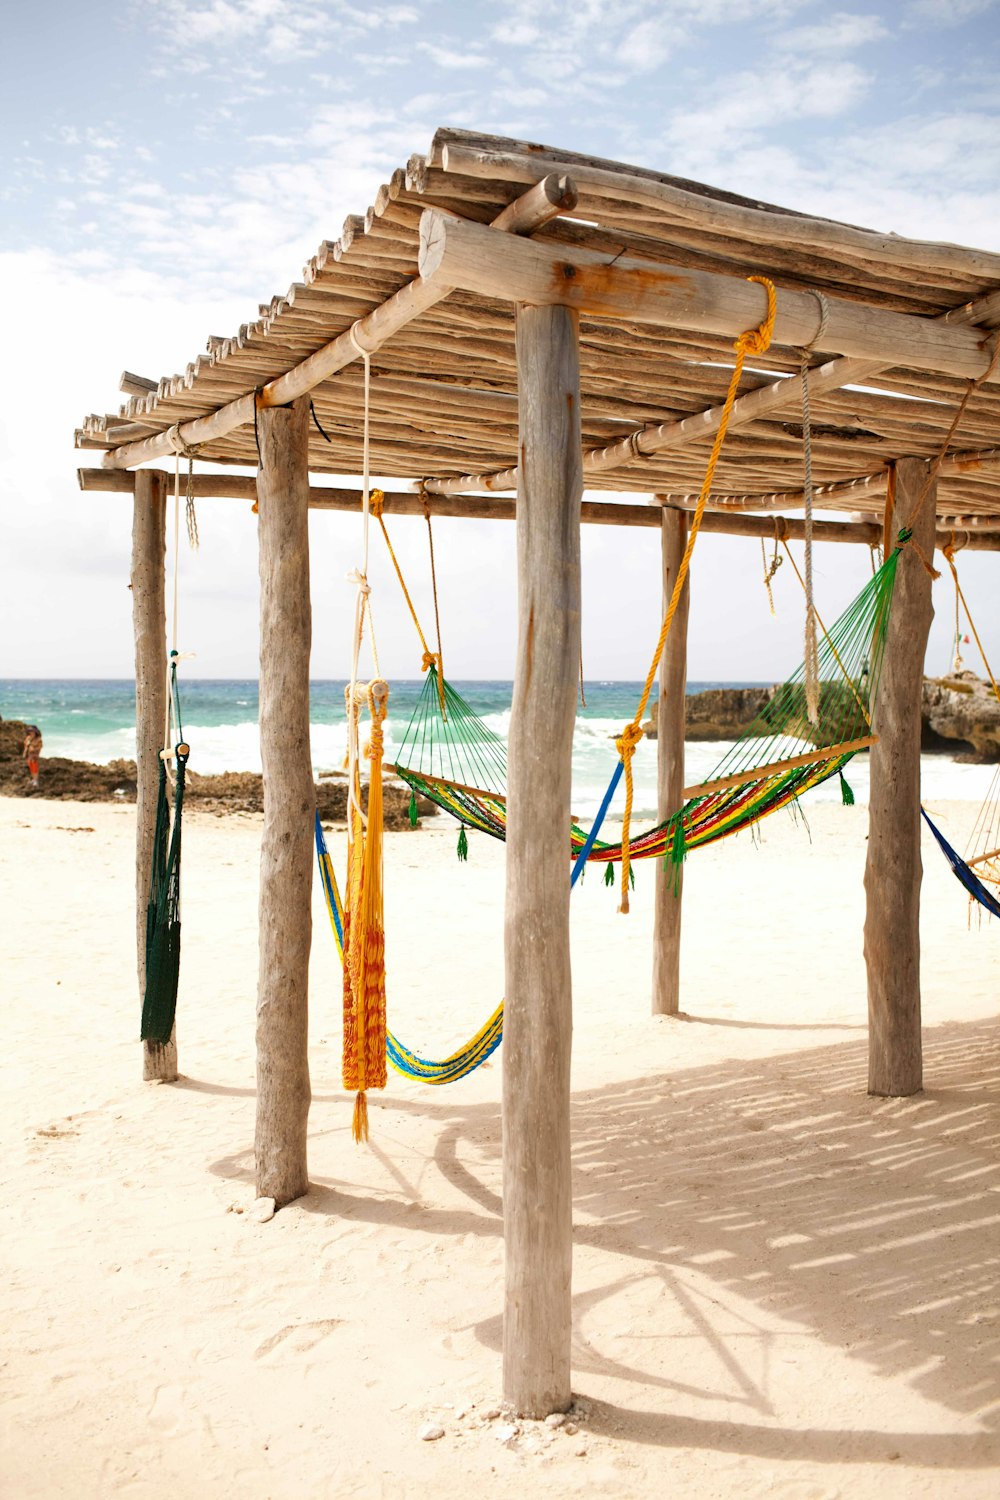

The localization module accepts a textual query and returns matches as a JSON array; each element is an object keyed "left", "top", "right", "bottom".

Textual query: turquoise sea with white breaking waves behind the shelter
[{"left": 0, "top": 680, "right": 993, "bottom": 818}]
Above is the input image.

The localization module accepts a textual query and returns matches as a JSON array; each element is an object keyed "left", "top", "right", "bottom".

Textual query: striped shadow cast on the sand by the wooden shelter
[{"left": 206, "top": 1023, "right": 1000, "bottom": 1469}]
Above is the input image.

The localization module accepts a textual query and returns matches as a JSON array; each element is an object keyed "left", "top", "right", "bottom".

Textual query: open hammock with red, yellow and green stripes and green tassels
[{"left": 396, "top": 548, "right": 900, "bottom": 864}]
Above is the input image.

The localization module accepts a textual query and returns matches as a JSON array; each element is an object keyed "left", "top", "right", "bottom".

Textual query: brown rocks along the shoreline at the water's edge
[{"left": 0, "top": 672, "right": 1000, "bottom": 830}]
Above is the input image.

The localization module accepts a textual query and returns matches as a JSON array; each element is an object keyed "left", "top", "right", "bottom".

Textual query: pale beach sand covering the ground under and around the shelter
[{"left": 0, "top": 800, "right": 1000, "bottom": 1500}]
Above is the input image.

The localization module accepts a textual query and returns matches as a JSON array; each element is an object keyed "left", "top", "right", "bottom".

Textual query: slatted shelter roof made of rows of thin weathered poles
[{"left": 78, "top": 131, "right": 1000, "bottom": 521}]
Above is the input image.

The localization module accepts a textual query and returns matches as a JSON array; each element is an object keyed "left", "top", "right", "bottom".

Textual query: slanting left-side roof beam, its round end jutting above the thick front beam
[{"left": 103, "top": 174, "right": 576, "bottom": 468}]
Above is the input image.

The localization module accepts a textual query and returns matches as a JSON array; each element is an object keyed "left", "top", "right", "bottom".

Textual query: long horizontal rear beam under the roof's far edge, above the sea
[{"left": 76, "top": 468, "right": 1000, "bottom": 552}]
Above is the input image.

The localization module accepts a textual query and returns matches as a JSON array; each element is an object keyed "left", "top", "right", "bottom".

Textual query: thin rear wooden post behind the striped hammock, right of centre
[{"left": 652, "top": 506, "right": 690, "bottom": 1016}]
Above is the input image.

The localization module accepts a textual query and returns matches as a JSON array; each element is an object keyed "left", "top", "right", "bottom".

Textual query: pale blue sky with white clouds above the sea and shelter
[{"left": 0, "top": 0, "right": 1000, "bottom": 678}]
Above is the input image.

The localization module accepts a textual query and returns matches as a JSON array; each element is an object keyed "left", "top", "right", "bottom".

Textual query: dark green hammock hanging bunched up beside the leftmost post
[{"left": 139, "top": 663, "right": 189, "bottom": 1046}]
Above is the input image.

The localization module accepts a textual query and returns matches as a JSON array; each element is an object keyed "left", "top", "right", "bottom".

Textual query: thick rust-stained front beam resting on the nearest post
[{"left": 418, "top": 209, "right": 1000, "bottom": 380}]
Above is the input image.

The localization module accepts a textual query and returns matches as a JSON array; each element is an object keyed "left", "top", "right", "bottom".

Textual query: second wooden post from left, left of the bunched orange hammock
[{"left": 255, "top": 398, "right": 316, "bottom": 1208}]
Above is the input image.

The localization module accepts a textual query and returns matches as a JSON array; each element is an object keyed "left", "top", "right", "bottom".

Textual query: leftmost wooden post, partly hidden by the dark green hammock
[{"left": 130, "top": 470, "right": 177, "bottom": 1083}]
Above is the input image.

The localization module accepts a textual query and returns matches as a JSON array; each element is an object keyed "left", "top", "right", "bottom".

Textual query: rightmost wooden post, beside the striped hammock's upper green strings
[{"left": 865, "top": 459, "right": 936, "bottom": 1098}]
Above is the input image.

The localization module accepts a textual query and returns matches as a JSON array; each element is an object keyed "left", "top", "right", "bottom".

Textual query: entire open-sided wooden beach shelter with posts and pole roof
[{"left": 76, "top": 131, "right": 1000, "bottom": 1416}]
